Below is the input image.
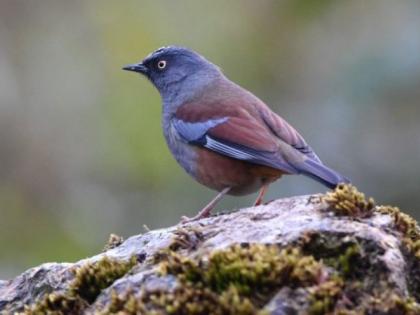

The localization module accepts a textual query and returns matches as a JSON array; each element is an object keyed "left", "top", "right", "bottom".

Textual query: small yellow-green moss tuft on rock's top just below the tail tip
[{"left": 321, "top": 184, "right": 375, "bottom": 218}]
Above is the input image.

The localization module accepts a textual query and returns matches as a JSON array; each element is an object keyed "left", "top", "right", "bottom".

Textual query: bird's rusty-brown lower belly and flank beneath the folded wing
[{"left": 195, "top": 147, "right": 283, "bottom": 195}]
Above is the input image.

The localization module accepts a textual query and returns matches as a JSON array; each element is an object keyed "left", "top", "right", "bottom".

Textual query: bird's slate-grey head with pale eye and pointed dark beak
[{"left": 123, "top": 46, "right": 221, "bottom": 106}]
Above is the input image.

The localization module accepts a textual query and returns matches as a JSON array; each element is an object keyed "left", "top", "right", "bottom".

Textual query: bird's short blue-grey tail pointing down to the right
[{"left": 299, "top": 159, "right": 350, "bottom": 189}]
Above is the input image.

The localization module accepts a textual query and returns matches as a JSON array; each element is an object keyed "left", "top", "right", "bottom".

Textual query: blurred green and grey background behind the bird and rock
[{"left": 0, "top": 0, "right": 420, "bottom": 279}]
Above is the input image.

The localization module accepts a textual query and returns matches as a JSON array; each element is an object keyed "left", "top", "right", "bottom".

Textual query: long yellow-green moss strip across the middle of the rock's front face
[{"left": 160, "top": 245, "right": 322, "bottom": 299}]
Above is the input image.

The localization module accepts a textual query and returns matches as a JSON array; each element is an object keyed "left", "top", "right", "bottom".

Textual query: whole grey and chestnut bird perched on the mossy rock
[{"left": 123, "top": 46, "right": 350, "bottom": 222}]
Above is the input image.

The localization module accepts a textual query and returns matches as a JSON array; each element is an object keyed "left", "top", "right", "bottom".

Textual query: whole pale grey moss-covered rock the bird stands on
[{"left": 0, "top": 186, "right": 420, "bottom": 314}]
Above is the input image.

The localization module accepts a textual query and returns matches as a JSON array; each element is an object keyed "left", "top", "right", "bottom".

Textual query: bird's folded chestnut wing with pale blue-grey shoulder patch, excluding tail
[{"left": 172, "top": 104, "right": 305, "bottom": 174}]
